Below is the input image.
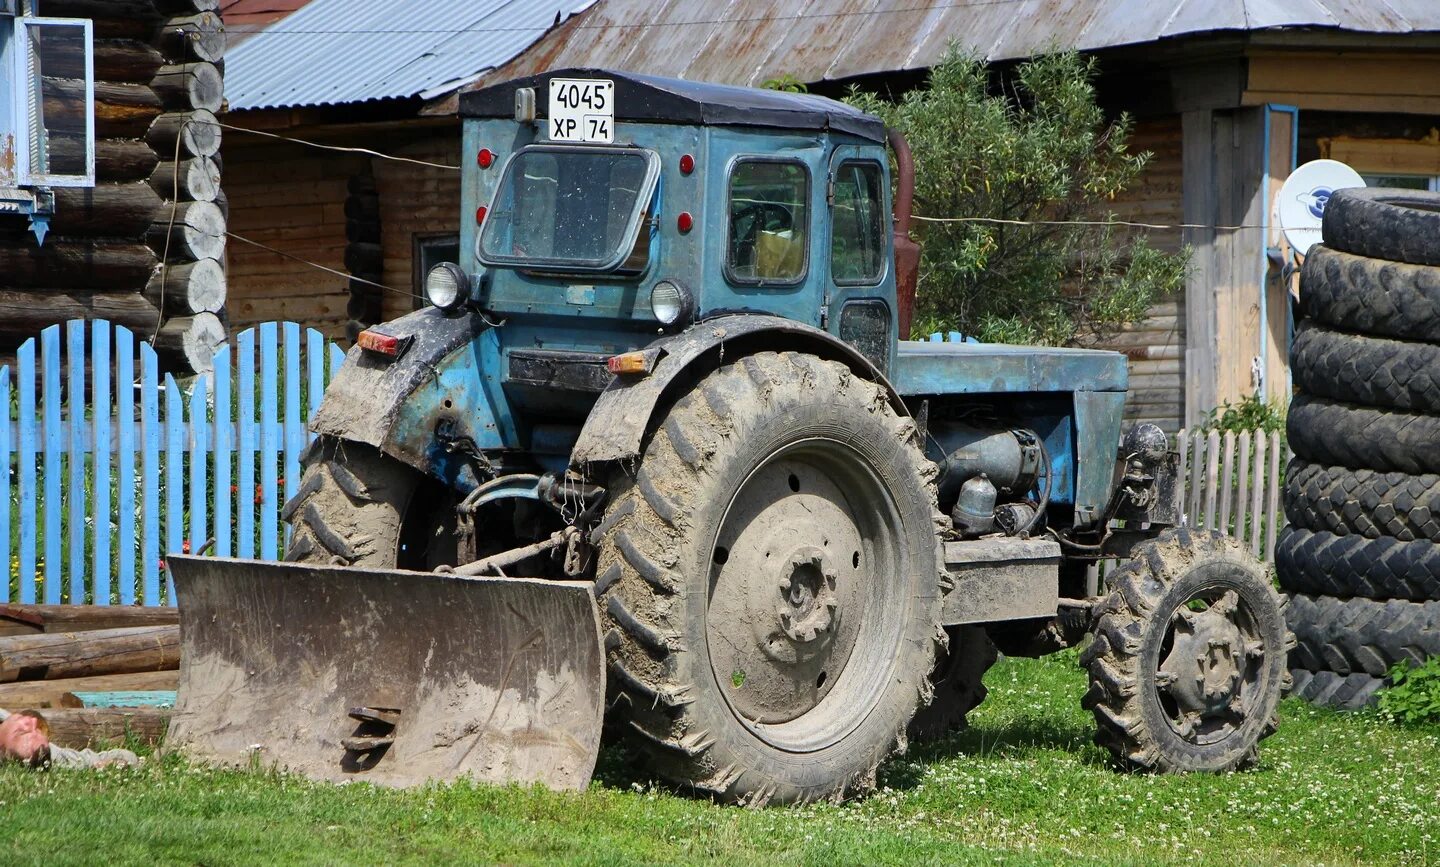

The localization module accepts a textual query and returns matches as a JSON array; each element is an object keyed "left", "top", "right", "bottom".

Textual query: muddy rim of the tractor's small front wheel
[{"left": 1155, "top": 582, "right": 1269, "bottom": 746}]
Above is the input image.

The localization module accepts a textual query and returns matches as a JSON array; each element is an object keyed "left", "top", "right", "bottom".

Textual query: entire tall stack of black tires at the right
[{"left": 1274, "top": 189, "right": 1440, "bottom": 709}]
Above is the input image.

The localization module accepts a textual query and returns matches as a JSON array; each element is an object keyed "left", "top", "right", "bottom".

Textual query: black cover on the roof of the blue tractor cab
[{"left": 459, "top": 69, "right": 886, "bottom": 143}]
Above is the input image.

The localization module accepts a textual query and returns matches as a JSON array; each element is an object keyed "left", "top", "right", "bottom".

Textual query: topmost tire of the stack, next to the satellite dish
[{"left": 1320, "top": 187, "right": 1440, "bottom": 265}]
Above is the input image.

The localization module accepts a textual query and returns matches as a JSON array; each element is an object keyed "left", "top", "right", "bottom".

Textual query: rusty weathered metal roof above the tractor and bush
[{"left": 477, "top": 0, "right": 1440, "bottom": 86}]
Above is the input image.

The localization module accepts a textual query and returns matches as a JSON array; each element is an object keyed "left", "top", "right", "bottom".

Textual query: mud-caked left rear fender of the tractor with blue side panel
[{"left": 310, "top": 307, "right": 513, "bottom": 488}]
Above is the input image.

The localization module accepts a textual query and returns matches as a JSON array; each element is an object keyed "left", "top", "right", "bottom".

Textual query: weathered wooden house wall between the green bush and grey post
[{"left": 1099, "top": 115, "right": 1185, "bottom": 432}]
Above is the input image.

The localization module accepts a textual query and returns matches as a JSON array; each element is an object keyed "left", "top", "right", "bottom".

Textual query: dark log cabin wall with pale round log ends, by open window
[{"left": 0, "top": 0, "right": 226, "bottom": 370}]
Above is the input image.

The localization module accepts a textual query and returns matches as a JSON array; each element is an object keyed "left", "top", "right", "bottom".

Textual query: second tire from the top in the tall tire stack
[{"left": 1300, "top": 245, "right": 1440, "bottom": 343}]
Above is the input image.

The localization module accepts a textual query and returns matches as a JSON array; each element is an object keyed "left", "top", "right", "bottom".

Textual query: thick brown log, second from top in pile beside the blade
[{"left": 0, "top": 625, "right": 180, "bottom": 683}]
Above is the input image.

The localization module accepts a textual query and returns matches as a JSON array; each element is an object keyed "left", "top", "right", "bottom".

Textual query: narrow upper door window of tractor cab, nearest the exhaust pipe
[{"left": 829, "top": 161, "right": 887, "bottom": 287}]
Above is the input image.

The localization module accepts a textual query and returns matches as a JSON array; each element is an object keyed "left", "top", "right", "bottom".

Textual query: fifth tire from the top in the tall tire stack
[{"left": 1284, "top": 458, "right": 1440, "bottom": 542}]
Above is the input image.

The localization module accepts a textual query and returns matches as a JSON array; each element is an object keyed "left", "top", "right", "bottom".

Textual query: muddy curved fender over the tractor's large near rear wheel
[{"left": 570, "top": 314, "right": 910, "bottom": 468}]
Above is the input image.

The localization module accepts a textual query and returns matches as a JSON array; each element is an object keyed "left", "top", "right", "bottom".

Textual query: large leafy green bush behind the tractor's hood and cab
[{"left": 848, "top": 46, "right": 1188, "bottom": 344}]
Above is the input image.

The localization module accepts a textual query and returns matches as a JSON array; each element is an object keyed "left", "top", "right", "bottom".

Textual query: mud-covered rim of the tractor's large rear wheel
[{"left": 706, "top": 439, "right": 909, "bottom": 752}]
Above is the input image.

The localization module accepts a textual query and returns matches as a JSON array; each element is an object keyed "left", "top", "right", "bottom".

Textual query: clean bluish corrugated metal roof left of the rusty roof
[{"left": 225, "top": 0, "right": 593, "bottom": 109}]
